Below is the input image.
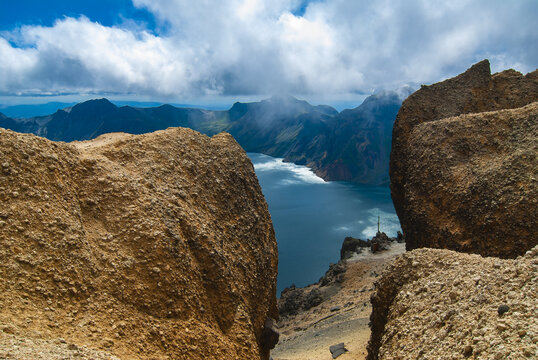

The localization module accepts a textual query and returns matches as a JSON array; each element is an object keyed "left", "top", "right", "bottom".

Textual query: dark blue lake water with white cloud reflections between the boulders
[{"left": 248, "top": 153, "right": 400, "bottom": 296}]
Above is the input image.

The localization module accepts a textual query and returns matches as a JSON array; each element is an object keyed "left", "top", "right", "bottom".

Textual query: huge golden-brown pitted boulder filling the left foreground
[{"left": 0, "top": 128, "right": 278, "bottom": 359}]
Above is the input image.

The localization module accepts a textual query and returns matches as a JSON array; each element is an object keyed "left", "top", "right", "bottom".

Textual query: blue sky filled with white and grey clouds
[{"left": 0, "top": 0, "right": 538, "bottom": 104}]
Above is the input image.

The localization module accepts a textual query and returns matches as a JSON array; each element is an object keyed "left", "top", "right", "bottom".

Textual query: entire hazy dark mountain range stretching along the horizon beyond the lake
[{"left": 0, "top": 91, "right": 409, "bottom": 185}]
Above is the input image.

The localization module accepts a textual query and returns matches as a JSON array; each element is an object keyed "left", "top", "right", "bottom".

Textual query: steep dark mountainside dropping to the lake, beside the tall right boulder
[{"left": 286, "top": 92, "right": 402, "bottom": 185}]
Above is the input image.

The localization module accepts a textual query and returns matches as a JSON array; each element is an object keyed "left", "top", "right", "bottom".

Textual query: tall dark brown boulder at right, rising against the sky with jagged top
[{"left": 390, "top": 60, "right": 538, "bottom": 258}]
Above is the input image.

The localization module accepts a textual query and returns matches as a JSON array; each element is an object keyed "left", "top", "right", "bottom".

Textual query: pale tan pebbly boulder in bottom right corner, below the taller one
[{"left": 368, "top": 246, "right": 538, "bottom": 360}]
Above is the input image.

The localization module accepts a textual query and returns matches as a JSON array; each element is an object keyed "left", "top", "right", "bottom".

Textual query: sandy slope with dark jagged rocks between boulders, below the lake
[{"left": 271, "top": 233, "right": 405, "bottom": 360}]
